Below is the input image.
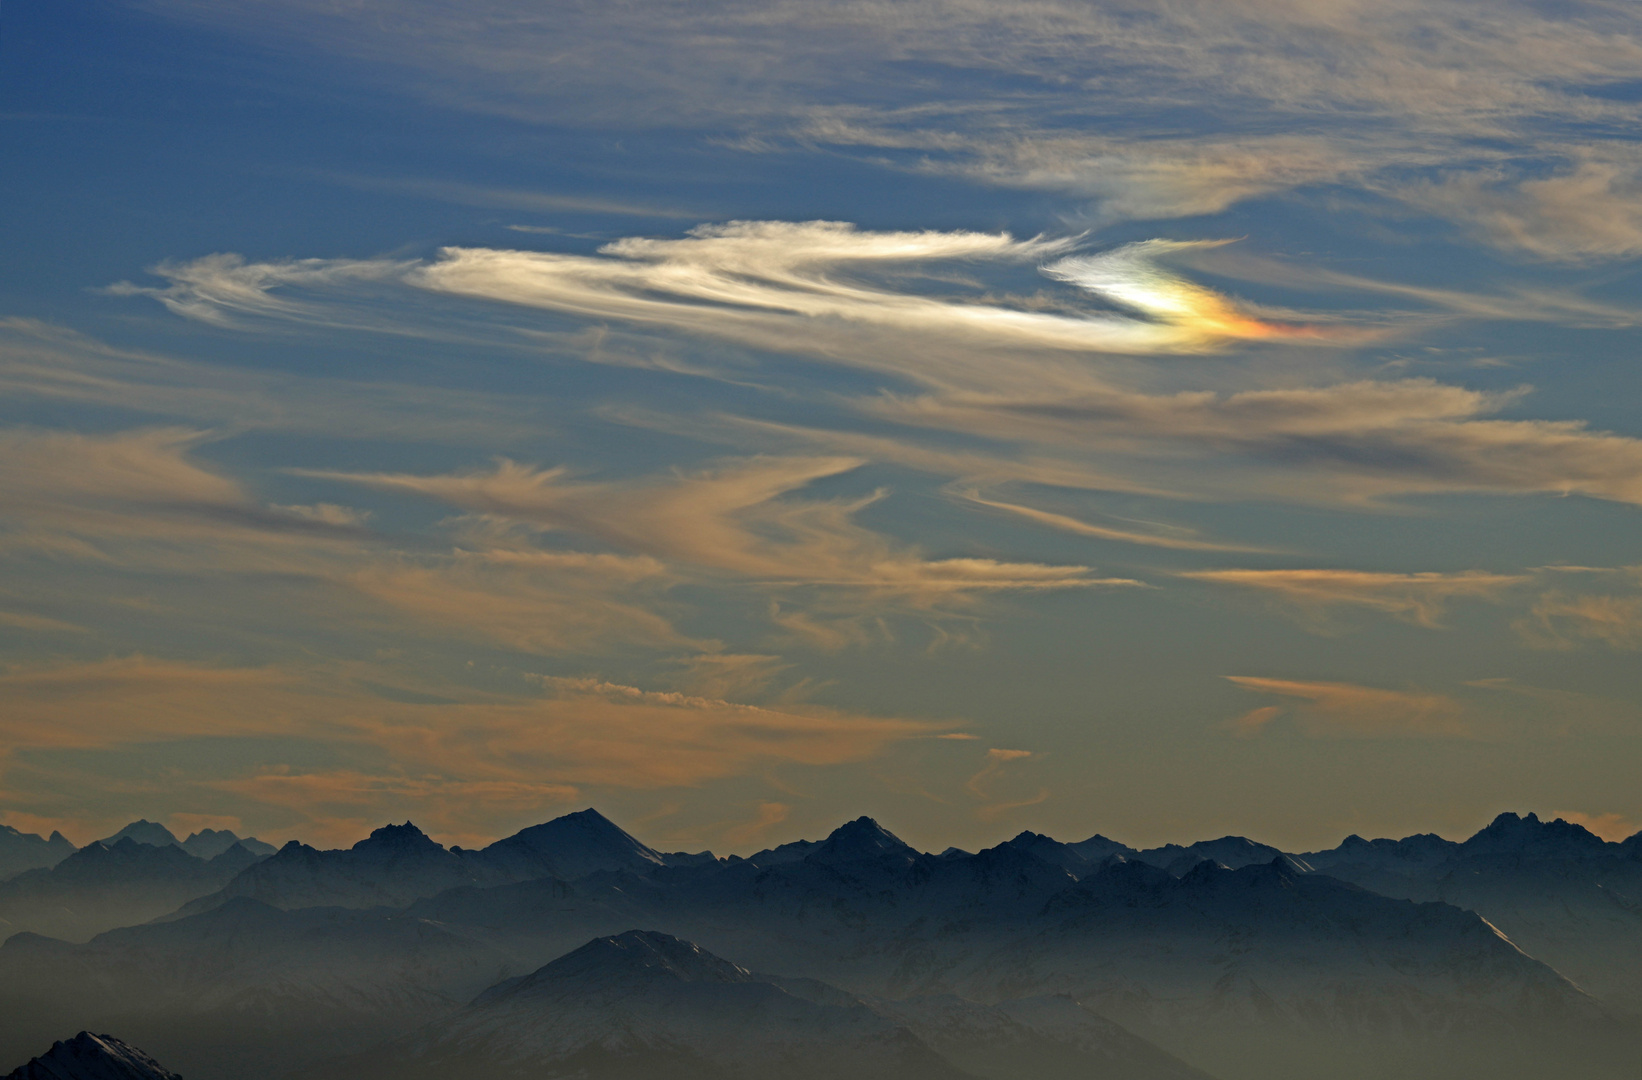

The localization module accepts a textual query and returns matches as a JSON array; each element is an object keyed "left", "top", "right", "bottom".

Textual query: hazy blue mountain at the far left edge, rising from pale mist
[{"left": 0, "top": 835, "right": 256, "bottom": 940}]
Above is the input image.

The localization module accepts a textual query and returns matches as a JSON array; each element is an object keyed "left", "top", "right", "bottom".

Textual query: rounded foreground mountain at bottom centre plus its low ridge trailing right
[{"left": 308, "top": 931, "right": 1207, "bottom": 1080}]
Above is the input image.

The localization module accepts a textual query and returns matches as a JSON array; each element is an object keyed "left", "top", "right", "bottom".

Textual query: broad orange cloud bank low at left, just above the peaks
[{"left": 0, "top": 657, "right": 941, "bottom": 839}]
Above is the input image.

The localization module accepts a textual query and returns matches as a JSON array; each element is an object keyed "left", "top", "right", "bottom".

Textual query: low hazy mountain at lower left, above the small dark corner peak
[{"left": 0, "top": 898, "right": 521, "bottom": 1080}]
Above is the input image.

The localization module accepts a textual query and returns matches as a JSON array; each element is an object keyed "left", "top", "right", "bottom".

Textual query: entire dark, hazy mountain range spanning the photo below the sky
[{"left": 0, "top": 809, "right": 1642, "bottom": 1080}]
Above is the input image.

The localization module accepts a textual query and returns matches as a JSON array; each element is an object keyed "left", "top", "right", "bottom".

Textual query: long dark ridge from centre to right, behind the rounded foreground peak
[{"left": 394, "top": 821, "right": 1626, "bottom": 1080}]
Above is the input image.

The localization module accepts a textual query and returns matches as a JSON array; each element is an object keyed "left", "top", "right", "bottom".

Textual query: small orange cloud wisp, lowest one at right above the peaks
[{"left": 1227, "top": 675, "right": 1473, "bottom": 739}]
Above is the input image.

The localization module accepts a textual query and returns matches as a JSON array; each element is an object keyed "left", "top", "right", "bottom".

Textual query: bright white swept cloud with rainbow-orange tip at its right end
[{"left": 128, "top": 222, "right": 1363, "bottom": 366}]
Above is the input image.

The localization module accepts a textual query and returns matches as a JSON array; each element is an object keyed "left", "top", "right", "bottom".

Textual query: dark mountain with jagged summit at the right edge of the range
[{"left": 1300, "top": 814, "right": 1642, "bottom": 1018}]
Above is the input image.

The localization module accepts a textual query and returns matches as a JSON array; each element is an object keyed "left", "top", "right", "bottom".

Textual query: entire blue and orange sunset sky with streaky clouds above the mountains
[{"left": 0, "top": 0, "right": 1642, "bottom": 853}]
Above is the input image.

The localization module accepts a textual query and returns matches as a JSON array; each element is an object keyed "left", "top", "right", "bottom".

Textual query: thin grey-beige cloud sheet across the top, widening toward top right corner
[{"left": 154, "top": 0, "right": 1642, "bottom": 247}]
